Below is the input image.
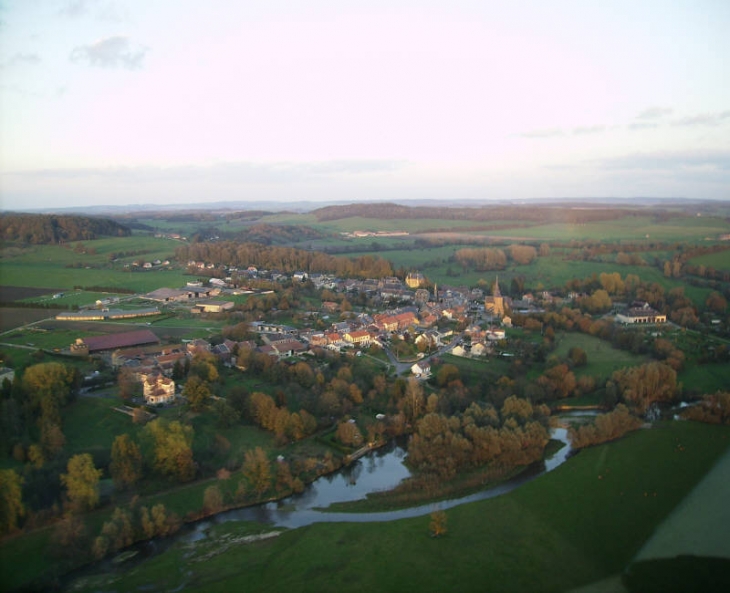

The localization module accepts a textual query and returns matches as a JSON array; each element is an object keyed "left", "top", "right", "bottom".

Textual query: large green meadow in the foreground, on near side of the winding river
[{"left": 58, "top": 422, "right": 730, "bottom": 593}]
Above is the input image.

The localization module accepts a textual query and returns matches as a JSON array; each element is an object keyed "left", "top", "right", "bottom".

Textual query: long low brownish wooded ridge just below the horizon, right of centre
[{"left": 312, "top": 202, "right": 661, "bottom": 224}]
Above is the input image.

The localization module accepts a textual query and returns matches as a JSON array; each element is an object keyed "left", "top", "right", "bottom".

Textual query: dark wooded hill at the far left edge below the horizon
[{"left": 0, "top": 214, "right": 132, "bottom": 245}]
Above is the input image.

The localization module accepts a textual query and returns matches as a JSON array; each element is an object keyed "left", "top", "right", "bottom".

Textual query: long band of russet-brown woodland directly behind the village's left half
[{"left": 175, "top": 241, "right": 393, "bottom": 278}]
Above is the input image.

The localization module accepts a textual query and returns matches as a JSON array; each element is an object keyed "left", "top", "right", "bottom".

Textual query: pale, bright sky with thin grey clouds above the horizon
[{"left": 0, "top": 0, "right": 730, "bottom": 210}]
